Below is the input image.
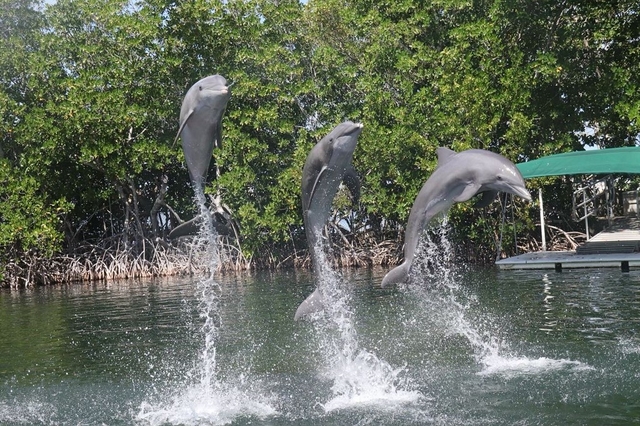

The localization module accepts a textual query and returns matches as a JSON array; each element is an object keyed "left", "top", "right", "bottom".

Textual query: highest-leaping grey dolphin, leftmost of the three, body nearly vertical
[{"left": 174, "top": 74, "right": 231, "bottom": 186}]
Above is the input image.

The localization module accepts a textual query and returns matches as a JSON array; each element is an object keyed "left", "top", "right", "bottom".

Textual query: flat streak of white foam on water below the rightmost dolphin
[{"left": 477, "top": 355, "right": 593, "bottom": 376}]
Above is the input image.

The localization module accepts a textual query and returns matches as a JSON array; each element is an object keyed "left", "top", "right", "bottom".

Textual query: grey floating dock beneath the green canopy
[{"left": 496, "top": 217, "right": 640, "bottom": 271}]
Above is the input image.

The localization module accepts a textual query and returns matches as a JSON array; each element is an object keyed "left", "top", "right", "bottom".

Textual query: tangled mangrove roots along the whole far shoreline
[{"left": 0, "top": 228, "right": 581, "bottom": 289}]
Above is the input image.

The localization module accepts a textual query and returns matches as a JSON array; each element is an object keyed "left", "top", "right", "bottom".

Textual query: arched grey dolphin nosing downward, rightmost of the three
[{"left": 381, "top": 148, "right": 531, "bottom": 287}]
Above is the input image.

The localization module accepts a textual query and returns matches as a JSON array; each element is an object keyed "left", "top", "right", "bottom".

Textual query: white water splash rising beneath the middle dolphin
[{"left": 306, "top": 240, "right": 421, "bottom": 413}]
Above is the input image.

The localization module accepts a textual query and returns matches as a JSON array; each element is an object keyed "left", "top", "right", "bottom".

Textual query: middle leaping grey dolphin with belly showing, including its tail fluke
[{"left": 294, "top": 121, "right": 362, "bottom": 320}]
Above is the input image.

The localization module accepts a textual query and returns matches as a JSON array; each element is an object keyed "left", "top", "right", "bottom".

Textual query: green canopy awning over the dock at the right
[{"left": 516, "top": 146, "right": 640, "bottom": 179}]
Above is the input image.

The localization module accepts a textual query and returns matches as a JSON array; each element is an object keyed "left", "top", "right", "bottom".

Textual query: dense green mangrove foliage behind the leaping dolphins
[{"left": 0, "top": 0, "right": 640, "bottom": 272}]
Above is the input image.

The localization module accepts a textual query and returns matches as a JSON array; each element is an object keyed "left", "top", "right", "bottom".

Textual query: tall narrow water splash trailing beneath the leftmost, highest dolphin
[{"left": 136, "top": 185, "right": 277, "bottom": 425}]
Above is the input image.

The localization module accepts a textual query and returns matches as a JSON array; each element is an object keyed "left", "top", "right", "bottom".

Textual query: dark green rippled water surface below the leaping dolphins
[{"left": 0, "top": 269, "right": 640, "bottom": 425}]
